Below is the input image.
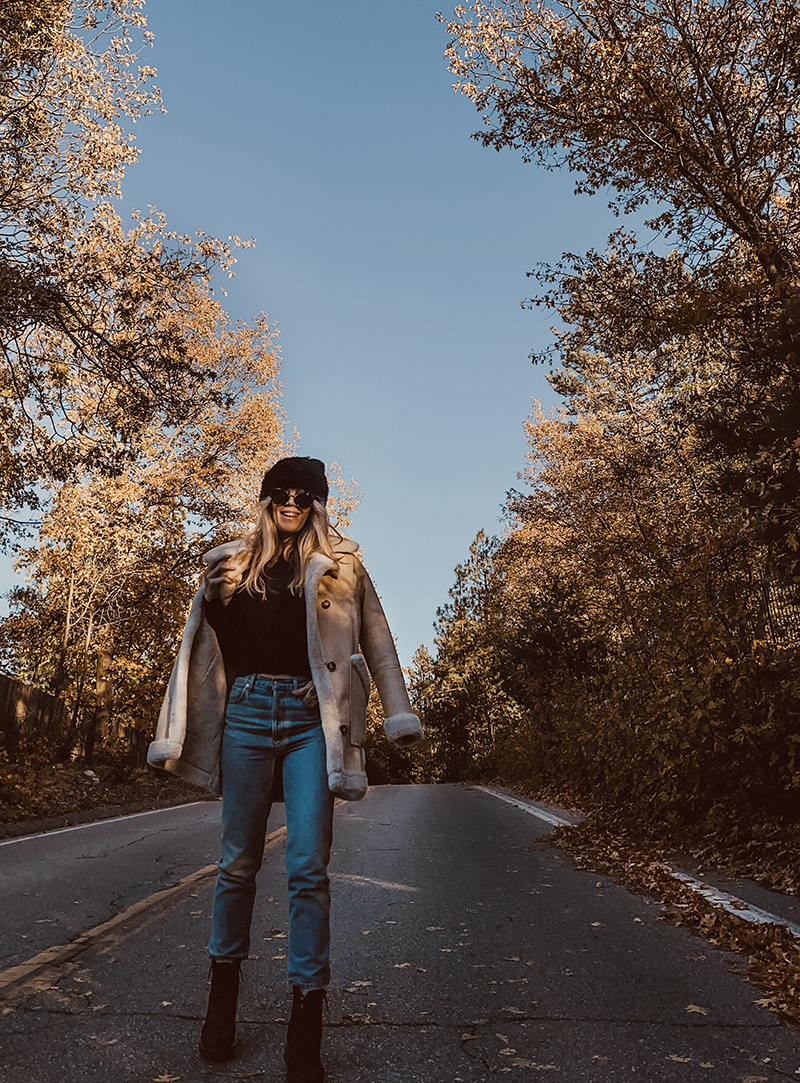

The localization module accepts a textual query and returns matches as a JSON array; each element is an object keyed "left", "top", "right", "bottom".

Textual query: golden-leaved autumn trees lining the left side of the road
[{"left": 0, "top": 0, "right": 318, "bottom": 754}]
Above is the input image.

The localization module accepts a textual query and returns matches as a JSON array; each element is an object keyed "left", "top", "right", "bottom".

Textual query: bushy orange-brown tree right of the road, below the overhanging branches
[{"left": 498, "top": 361, "right": 800, "bottom": 825}]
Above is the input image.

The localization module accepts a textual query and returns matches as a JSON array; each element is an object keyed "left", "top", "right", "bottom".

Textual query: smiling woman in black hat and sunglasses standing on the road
[{"left": 148, "top": 458, "right": 422, "bottom": 1083}]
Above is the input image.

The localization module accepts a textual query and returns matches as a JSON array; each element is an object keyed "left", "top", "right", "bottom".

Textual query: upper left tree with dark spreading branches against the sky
[{"left": 0, "top": 0, "right": 252, "bottom": 529}]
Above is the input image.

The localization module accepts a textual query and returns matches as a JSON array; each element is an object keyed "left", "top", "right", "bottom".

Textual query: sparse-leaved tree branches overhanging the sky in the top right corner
[{"left": 447, "top": 0, "right": 800, "bottom": 288}]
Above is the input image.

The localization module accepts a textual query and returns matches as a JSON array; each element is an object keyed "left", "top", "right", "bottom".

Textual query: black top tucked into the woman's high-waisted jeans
[{"left": 204, "top": 558, "right": 311, "bottom": 677}]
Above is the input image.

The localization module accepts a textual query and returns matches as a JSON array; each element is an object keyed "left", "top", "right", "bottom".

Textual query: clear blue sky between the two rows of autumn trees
[{"left": 1, "top": 0, "right": 618, "bottom": 664}]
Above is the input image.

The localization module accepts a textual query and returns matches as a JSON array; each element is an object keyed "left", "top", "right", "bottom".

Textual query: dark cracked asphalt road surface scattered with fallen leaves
[{"left": 0, "top": 786, "right": 800, "bottom": 1083}]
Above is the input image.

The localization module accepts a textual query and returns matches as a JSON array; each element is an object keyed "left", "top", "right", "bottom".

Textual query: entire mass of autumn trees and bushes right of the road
[{"left": 419, "top": 0, "right": 800, "bottom": 827}]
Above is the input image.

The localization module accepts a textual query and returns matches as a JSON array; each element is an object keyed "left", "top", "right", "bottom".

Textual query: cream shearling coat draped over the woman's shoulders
[{"left": 147, "top": 538, "right": 422, "bottom": 800}]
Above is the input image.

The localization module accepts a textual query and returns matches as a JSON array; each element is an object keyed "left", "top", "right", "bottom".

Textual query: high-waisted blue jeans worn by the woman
[{"left": 208, "top": 675, "right": 333, "bottom": 989}]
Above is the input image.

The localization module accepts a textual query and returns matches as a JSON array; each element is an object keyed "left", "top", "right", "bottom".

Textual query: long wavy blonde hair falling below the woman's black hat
[{"left": 237, "top": 496, "right": 342, "bottom": 598}]
